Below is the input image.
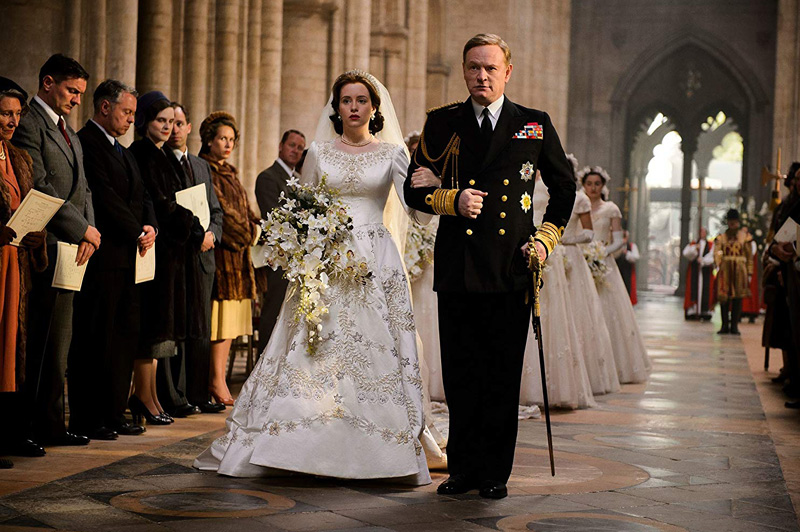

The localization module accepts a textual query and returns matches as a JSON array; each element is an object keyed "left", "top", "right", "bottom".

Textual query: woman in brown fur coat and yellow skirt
[{"left": 200, "top": 111, "right": 258, "bottom": 405}]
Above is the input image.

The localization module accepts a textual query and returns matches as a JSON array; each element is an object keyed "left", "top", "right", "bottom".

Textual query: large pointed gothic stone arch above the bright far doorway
[{"left": 610, "top": 30, "right": 772, "bottom": 290}]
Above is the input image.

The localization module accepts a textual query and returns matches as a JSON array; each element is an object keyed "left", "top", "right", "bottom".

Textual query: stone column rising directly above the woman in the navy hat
[{"left": 136, "top": 0, "right": 173, "bottom": 95}]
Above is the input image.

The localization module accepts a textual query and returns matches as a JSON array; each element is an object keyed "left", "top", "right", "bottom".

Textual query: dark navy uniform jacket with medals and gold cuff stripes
[{"left": 403, "top": 97, "right": 575, "bottom": 293}]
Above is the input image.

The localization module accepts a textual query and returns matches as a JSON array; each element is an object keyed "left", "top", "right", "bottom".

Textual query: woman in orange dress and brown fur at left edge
[{"left": 0, "top": 77, "right": 47, "bottom": 467}]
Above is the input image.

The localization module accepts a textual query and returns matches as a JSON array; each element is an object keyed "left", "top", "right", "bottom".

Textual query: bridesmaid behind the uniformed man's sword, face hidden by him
[{"left": 520, "top": 177, "right": 596, "bottom": 408}]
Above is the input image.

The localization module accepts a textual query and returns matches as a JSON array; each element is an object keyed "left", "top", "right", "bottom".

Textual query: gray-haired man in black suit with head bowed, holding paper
[{"left": 69, "top": 79, "right": 157, "bottom": 440}]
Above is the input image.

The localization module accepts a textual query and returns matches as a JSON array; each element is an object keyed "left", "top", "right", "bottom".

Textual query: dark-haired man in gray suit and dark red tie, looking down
[{"left": 14, "top": 54, "right": 100, "bottom": 445}]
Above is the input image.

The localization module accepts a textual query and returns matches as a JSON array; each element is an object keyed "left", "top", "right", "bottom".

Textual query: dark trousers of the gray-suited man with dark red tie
[{"left": 25, "top": 262, "right": 75, "bottom": 441}]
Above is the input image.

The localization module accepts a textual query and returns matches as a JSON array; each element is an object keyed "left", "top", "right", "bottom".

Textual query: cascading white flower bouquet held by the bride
[{"left": 258, "top": 175, "right": 372, "bottom": 355}]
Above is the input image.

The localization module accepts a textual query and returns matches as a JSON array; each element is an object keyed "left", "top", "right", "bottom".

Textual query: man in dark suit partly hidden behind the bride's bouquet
[{"left": 256, "top": 129, "right": 306, "bottom": 353}]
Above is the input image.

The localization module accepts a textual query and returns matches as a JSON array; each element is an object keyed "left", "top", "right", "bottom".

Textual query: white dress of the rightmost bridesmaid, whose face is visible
[{"left": 592, "top": 201, "right": 651, "bottom": 384}]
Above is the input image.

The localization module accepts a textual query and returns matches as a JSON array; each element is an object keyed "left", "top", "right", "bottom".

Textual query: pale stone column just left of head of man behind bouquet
[{"left": 253, "top": 0, "right": 286, "bottom": 195}]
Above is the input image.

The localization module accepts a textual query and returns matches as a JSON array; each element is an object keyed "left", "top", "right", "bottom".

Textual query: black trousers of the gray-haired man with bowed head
[{"left": 69, "top": 270, "right": 140, "bottom": 434}]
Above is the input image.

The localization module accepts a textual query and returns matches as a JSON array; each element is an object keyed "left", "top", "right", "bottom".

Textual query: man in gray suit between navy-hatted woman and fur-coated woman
[{"left": 157, "top": 102, "right": 225, "bottom": 417}]
